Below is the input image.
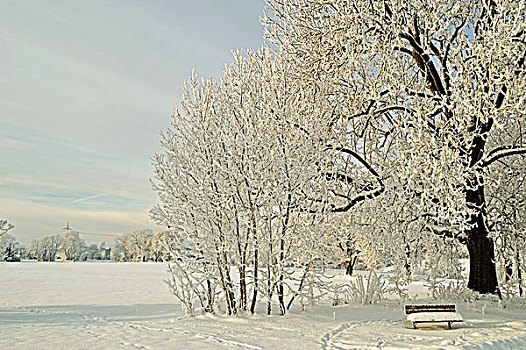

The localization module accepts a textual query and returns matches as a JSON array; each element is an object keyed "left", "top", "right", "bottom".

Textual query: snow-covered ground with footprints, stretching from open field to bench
[{"left": 0, "top": 262, "right": 526, "bottom": 349}]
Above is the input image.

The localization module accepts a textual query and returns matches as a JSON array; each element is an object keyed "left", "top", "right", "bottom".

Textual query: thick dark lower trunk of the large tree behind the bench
[{"left": 466, "top": 178, "right": 499, "bottom": 294}]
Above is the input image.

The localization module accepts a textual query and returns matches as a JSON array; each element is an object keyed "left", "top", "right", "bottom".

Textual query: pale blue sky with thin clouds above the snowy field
[{"left": 0, "top": 0, "right": 264, "bottom": 243}]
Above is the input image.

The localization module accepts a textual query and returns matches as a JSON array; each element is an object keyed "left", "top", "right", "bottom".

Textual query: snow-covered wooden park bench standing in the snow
[{"left": 405, "top": 304, "right": 464, "bottom": 329}]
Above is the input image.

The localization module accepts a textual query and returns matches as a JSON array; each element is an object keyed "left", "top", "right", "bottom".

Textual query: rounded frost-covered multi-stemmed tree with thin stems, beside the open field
[{"left": 152, "top": 49, "right": 340, "bottom": 314}]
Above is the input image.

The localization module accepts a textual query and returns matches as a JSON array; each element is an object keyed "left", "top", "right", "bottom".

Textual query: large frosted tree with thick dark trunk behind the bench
[{"left": 265, "top": 0, "right": 526, "bottom": 293}]
